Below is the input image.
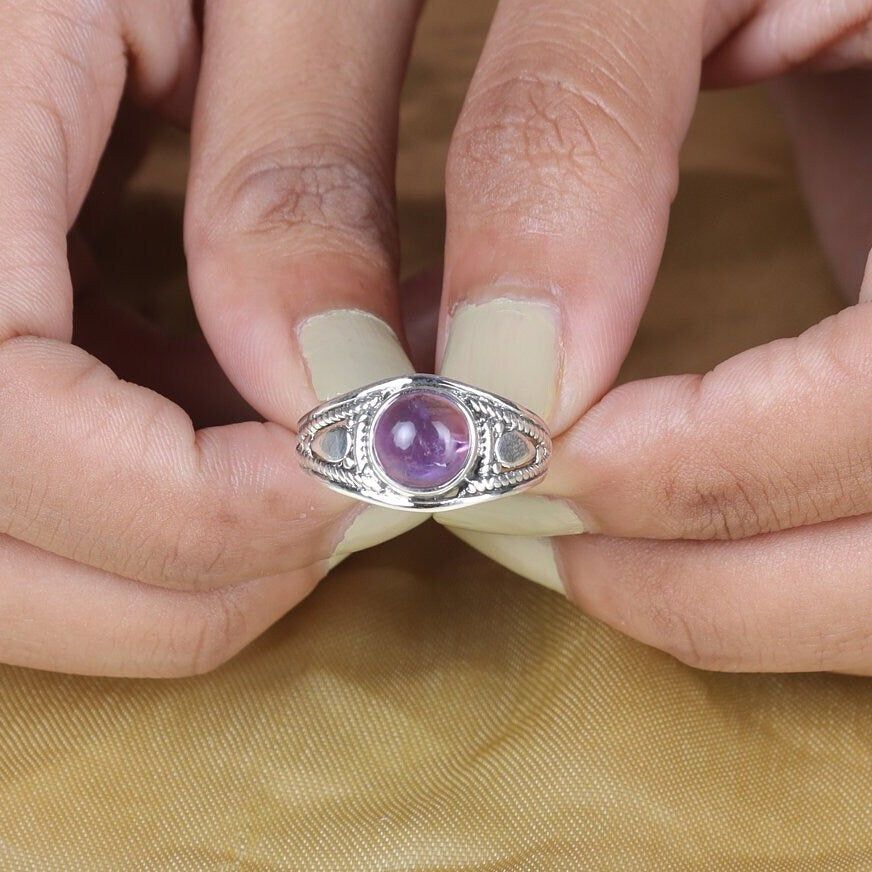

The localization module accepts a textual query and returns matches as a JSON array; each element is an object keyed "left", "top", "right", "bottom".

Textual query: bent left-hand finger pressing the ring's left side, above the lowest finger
[{"left": 0, "top": 337, "right": 364, "bottom": 589}]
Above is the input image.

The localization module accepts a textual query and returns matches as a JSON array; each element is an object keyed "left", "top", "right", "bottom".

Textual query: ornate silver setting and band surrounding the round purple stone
[{"left": 297, "top": 375, "right": 552, "bottom": 512}]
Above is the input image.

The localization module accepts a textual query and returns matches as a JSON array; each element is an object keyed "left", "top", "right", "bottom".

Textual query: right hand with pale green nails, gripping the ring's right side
[{"left": 438, "top": 0, "right": 872, "bottom": 674}]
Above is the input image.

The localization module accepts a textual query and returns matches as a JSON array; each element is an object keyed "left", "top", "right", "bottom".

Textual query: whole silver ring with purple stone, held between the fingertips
[{"left": 297, "top": 375, "right": 551, "bottom": 512}]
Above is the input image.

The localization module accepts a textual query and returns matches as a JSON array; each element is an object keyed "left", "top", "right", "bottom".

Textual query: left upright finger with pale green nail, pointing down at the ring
[{"left": 186, "top": 0, "right": 420, "bottom": 426}]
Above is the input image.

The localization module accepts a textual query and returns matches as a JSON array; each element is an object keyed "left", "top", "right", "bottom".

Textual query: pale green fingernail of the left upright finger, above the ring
[{"left": 299, "top": 309, "right": 414, "bottom": 400}]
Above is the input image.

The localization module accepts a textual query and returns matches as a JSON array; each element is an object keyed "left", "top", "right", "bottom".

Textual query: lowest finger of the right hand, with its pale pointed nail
[{"left": 453, "top": 517, "right": 872, "bottom": 675}]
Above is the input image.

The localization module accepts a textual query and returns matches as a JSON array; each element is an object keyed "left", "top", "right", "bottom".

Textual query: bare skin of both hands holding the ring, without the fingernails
[{"left": 0, "top": 0, "right": 872, "bottom": 676}]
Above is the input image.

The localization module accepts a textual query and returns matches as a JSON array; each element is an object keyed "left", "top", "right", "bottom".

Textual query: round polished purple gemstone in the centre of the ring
[{"left": 373, "top": 390, "right": 471, "bottom": 490}]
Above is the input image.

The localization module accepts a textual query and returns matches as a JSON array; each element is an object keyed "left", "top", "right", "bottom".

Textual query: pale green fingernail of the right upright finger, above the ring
[{"left": 442, "top": 296, "right": 561, "bottom": 420}]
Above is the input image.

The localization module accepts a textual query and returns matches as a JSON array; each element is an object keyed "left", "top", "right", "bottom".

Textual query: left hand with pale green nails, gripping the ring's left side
[{"left": 0, "top": 0, "right": 430, "bottom": 676}]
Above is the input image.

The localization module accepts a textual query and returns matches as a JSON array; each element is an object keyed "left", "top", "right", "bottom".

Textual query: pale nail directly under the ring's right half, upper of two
[{"left": 433, "top": 494, "right": 585, "bottom": 536}]
